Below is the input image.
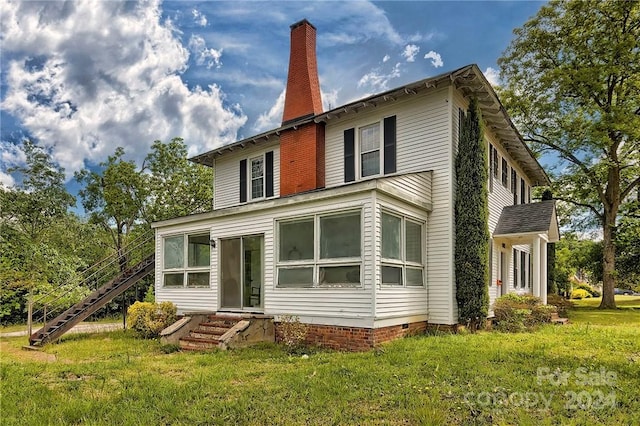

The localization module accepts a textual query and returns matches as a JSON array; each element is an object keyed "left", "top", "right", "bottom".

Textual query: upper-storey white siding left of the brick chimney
[{"left": 213, "top": 141, "right": 280, "bottom": 210}]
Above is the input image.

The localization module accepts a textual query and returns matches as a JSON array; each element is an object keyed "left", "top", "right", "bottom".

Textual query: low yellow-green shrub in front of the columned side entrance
[{"left": 493, "top": 293, "right": 555, "bottom": 332}]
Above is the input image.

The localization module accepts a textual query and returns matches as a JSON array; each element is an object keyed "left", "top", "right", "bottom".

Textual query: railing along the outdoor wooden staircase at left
[{"left": 28, "top": 231, "right": 155, "bottom": 336}]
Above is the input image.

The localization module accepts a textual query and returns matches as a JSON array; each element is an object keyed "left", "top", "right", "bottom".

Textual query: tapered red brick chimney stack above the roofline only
[{"left": 282, "top": 19, "right": 322, "bottom": 123}]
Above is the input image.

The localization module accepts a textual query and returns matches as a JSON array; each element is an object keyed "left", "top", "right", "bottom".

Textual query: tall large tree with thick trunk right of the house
[{"left": 498, "top": 0, "right": 640, "bottom": 308}]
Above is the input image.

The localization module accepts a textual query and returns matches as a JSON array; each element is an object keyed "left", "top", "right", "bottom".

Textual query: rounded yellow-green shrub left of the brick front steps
[{"left": 127, "top": 302, "right": 178, "bottom": 339}]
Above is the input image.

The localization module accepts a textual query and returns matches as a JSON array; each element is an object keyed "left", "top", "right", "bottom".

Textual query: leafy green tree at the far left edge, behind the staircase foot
[{"left": 0, "top": 141, "right": 84, "bottom": 322}]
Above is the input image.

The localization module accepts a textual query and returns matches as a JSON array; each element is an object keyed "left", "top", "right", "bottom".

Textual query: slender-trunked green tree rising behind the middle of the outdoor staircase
[{"left": 76, "top": 147, "right": 146, "bottom": 270}]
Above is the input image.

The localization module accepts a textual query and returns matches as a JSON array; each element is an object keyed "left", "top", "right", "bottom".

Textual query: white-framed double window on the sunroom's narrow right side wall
[{"left": 381, "top": 212, "right": 424, "bottom": 287}]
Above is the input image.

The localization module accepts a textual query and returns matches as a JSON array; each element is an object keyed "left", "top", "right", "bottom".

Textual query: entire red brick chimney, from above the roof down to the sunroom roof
[{"left": 280, "top": 19, "right": 325, "bottom": 196}]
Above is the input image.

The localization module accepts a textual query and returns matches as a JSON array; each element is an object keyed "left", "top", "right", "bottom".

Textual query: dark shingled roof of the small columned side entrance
[{"left": 493, "top": 200, "right": 558, "bottom": 237}]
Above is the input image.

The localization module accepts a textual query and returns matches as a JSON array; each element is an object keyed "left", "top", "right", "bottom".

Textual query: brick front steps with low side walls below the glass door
[{"left": 160, "top": 313, "right": 275, "bottom": 351}]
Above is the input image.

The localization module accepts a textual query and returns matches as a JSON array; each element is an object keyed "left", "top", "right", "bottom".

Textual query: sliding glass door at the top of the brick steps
[{"left": 220, "top": 235, "right": 264, "bottom": 310}]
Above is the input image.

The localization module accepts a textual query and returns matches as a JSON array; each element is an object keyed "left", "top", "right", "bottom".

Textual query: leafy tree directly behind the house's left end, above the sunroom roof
[{"left": 142, "top": 138, "right": 213, "bottom": 223}]
